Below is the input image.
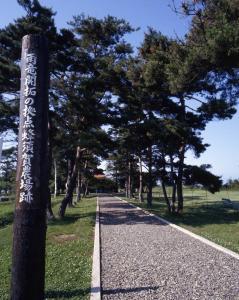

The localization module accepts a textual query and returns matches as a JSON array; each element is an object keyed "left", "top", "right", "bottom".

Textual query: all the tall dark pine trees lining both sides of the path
[{"left": 0, "top": 0, "right": 239, "bottom": 217}]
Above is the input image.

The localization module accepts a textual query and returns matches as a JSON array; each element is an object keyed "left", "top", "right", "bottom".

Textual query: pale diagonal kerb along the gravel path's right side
[{"left": 115, "top": 196, "right": 239, "bottom": 260}]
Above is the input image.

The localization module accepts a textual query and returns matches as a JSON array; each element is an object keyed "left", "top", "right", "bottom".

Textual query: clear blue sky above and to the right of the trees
[{"left": 0, "top": 0, "right": 239, "bottom": 179}]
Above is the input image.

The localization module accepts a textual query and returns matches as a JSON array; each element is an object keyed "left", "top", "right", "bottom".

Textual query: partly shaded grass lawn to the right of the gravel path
[{"left": 125, "top": 188, "right": 239, "bottom": 253}]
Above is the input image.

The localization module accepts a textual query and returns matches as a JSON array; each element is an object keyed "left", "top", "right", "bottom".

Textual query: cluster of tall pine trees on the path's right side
[{"left": 107, "top": 1, "right": 239, "bottom": 212}]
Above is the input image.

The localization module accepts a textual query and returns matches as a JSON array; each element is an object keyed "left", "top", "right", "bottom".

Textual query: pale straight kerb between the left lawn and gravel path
[{"left": 90, "top": 197, "right": 101, "bottom": 300}]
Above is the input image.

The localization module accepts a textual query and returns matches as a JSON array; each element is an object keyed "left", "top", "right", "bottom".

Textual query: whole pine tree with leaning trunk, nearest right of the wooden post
[{"left": 55, "top": 15, "right": 132, "bottom": 217}]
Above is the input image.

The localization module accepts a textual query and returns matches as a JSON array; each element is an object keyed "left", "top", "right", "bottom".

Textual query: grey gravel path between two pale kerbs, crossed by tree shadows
[{"left": 100, "top": 197, "right": 239, "bottom": 300}]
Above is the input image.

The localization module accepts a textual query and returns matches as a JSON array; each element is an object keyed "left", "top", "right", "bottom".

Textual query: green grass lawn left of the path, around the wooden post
[{"left": 0, "top": 198, "right": 96, "bottom": 300}]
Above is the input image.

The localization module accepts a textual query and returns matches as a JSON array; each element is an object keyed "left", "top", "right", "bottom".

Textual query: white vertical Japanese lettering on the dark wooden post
[{"left": 19, "top": 52, "right": 37, "bottom": 203}]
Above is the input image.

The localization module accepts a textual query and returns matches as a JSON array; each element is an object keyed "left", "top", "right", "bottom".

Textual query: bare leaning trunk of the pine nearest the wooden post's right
[{"left": 59, "top": 146, "right": 82, "bottom": 218}]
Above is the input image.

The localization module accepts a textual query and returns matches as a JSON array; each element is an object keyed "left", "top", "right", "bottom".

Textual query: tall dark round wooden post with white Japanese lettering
[{"left": 11, "top": 35, "right": 49, "bottom": 300}]
